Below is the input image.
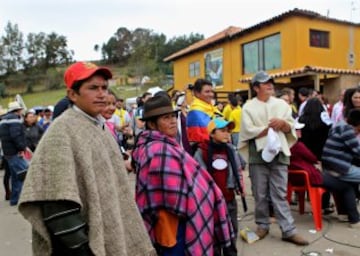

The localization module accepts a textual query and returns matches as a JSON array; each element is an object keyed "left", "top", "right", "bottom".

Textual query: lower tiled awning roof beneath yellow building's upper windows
[{"left": 239, "top": 66, "right": 360, "bottom": 83}]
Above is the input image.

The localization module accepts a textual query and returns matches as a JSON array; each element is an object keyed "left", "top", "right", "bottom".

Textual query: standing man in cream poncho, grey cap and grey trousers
[{"left": 240, "top": 71, "right": 309, "bottom": 245}]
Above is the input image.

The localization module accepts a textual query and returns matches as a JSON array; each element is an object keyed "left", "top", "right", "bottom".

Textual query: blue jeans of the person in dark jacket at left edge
[{"left": 6, "top": 155, "right": 28, "bottom": 205}]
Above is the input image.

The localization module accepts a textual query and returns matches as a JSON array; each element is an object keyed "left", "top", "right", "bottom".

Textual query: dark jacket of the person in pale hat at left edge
[{"left": 0, "top": 113, "right": 26, "bottom": 156}]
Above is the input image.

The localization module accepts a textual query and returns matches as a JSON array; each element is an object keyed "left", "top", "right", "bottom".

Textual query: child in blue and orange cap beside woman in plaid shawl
[{"left": 194, "top": 118, "right": 245, "bottom": 256}]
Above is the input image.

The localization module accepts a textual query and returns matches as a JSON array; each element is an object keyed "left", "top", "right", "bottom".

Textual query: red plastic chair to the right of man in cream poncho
[{"left": 287, "top": 170, "right": 325, "bottom": 231}]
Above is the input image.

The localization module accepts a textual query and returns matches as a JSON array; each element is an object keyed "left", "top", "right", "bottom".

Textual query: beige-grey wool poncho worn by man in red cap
[{"left": 19, "top": 109, "right": 156, "bottom": 256}]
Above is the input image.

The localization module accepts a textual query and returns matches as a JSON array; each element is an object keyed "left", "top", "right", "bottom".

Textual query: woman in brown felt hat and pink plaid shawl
[{"left": 132, "top": 96, "right": 234, "bottom": 256}]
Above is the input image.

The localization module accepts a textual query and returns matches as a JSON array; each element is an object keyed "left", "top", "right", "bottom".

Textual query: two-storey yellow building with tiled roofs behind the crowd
[{"left": 164, "top": 9, "right": 360, "bottom": 102}]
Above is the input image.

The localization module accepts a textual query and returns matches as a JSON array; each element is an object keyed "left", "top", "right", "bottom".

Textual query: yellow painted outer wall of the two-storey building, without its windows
[{"left": 174, "top": 16, "right": 360, "bottom": 94}]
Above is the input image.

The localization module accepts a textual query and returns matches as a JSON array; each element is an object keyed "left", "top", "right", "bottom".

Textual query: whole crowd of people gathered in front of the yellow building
[{"left": 0, "top": 62, "right": 360, "bottom": 256}]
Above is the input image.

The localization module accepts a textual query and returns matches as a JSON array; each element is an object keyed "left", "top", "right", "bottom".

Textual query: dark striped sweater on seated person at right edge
[{"left": 322, "top": 120, "right": 360, "bottom": 174}]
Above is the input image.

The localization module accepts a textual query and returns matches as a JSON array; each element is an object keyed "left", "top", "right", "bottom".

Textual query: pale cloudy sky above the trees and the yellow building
[{"left": 0, "top": 0, "right": 360, "bottom": 60}]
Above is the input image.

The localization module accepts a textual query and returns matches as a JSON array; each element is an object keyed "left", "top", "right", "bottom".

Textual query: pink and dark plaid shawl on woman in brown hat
[{"left": 133, "top": 130, "right": 234, "bottom": 255}]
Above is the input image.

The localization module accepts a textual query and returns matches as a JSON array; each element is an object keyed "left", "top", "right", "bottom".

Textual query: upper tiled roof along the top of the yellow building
[{"left": 164, "top": 8, "right": 360, "bottom": 62}]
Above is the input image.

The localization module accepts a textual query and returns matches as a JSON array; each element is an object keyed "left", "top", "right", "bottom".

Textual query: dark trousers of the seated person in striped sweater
[{"left": 323, "top": 172, "right": 360, "bottom": 223}]
